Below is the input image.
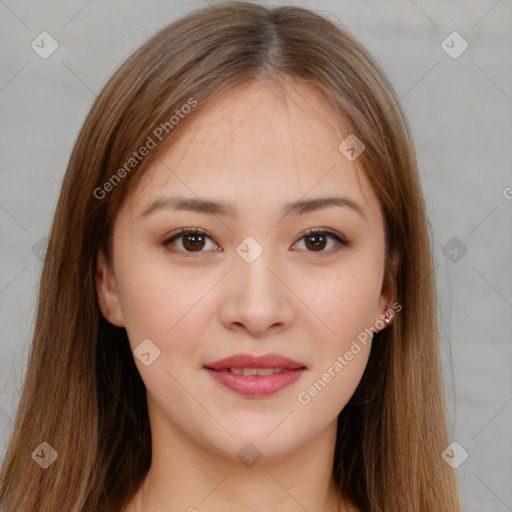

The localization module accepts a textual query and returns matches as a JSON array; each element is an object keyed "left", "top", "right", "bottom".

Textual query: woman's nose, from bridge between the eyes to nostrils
[{"left": 219, "top": 246, "right": 295, "bottom": 338}]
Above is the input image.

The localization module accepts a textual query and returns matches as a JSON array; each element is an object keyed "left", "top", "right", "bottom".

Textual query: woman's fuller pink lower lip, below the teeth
[{"left": 206, "top": 368, "right": 305, "bottom": 397}]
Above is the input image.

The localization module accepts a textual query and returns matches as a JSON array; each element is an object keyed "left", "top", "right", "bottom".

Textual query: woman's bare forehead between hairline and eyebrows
[{"left": 124, "top": 82, "right": 378, "bottom": 222}]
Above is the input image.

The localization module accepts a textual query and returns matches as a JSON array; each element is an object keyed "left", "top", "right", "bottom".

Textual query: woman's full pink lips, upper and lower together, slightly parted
[{"left": 204, "top": 354, "right": 306, "bottom": 397}]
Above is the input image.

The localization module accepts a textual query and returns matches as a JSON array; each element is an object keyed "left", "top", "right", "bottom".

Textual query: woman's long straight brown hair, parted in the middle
[{"left": 0, "top": 2, "right": 460, "bottom": 512}]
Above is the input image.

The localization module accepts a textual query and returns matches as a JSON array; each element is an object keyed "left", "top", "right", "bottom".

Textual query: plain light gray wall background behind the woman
[{"left": 0, "top": 0, "right": 512, "bottom": 512}]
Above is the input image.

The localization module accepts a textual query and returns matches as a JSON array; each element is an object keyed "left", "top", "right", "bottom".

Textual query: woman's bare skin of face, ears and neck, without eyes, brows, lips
[{"left": 96, "top": 77, "right": 394, "bottom": 512}]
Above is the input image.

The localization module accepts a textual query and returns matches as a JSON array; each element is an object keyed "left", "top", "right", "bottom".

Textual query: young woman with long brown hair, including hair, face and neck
[{"left": 0, "top": 2, "right": 459, "bottom": 512}]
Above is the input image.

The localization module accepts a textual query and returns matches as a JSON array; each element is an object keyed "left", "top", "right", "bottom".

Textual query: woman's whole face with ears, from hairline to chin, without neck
[{"left": 97, "top": 79, "right": 393, "bottom": 458}]
